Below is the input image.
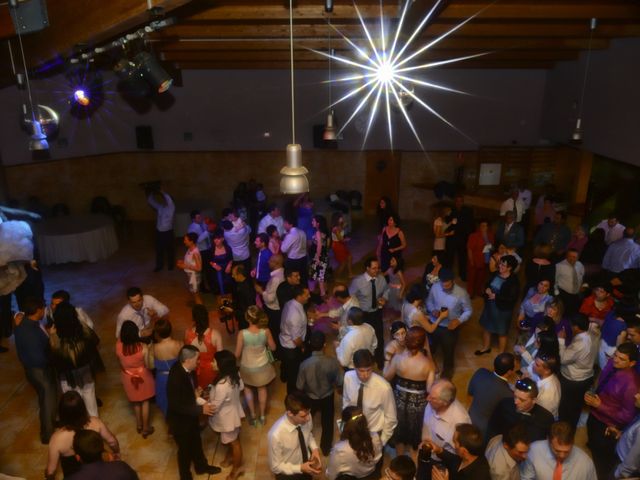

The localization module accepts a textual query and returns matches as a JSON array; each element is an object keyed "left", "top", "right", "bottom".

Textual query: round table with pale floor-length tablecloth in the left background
[{"left": 36, "top": 215, "right": 118, "bottom": 265}]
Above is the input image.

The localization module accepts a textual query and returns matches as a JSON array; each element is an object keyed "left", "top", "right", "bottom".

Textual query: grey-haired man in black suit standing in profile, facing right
[{"left": 167, "top": 345, "right": 220, "bottom": 480}]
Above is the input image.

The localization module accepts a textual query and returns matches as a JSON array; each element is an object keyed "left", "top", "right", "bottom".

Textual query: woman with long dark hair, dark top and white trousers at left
[{"left": 49, "top": 302, "right": 99, "bottom": 417}]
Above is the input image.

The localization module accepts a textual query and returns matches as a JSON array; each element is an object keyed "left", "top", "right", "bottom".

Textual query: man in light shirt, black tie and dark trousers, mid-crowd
[{"left": 349, "top": 257, "right": 389, "bottom": 370}]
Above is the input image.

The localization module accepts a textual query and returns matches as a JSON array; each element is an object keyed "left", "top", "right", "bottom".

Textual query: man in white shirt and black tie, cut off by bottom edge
[{"left": 267, "top": 392, "right": 322, "bottom": 480}]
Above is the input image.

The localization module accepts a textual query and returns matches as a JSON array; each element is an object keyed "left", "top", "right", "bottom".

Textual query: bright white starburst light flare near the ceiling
[{"left": 309, "top": 0, "right": 493, "bottom": 151}]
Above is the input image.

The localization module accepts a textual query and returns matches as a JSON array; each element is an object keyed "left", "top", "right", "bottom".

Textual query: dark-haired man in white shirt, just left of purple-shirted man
[{"left": 558, "top": 315, "right": 595, "bottom": 428}]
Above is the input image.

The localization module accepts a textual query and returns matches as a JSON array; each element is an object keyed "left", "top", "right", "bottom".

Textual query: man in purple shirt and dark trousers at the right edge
[{"left": 584, "top": 342, "right": 640, "bottom": 478}]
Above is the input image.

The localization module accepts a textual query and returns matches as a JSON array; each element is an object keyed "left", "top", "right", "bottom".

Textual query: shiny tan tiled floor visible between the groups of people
[{"left": 0, "top": 218, "right": 584, "bottom": 480}]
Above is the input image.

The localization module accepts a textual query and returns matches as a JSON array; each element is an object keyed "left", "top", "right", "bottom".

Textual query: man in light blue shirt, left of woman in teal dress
[{"left": 426, "top": 268, "right": 473, "bottom": 379}]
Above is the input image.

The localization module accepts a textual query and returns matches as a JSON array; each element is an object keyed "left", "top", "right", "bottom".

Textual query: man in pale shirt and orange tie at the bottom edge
[{"left": 520, "top": 422, "right": 598, "bottom": 480}]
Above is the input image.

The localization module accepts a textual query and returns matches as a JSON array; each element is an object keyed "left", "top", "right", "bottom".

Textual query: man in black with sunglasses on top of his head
[{"left": 487, "top": 378, "right": 554, "bottom": 442}]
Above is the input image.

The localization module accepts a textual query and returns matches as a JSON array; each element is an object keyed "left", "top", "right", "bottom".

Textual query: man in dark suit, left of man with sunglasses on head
[{"left": 467, "top": 352, "right": 515, "bottom": 444}]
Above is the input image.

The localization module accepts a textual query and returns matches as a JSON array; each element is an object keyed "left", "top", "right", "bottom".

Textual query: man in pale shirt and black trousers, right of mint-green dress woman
[{"left": 280, "top": 285, "right": 310, "bottom": 393}]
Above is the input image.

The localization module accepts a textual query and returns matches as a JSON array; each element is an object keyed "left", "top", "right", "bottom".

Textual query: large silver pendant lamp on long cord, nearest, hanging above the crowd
[{"left": 280, "top": 0, "right": 309, "bottom": 194}]
